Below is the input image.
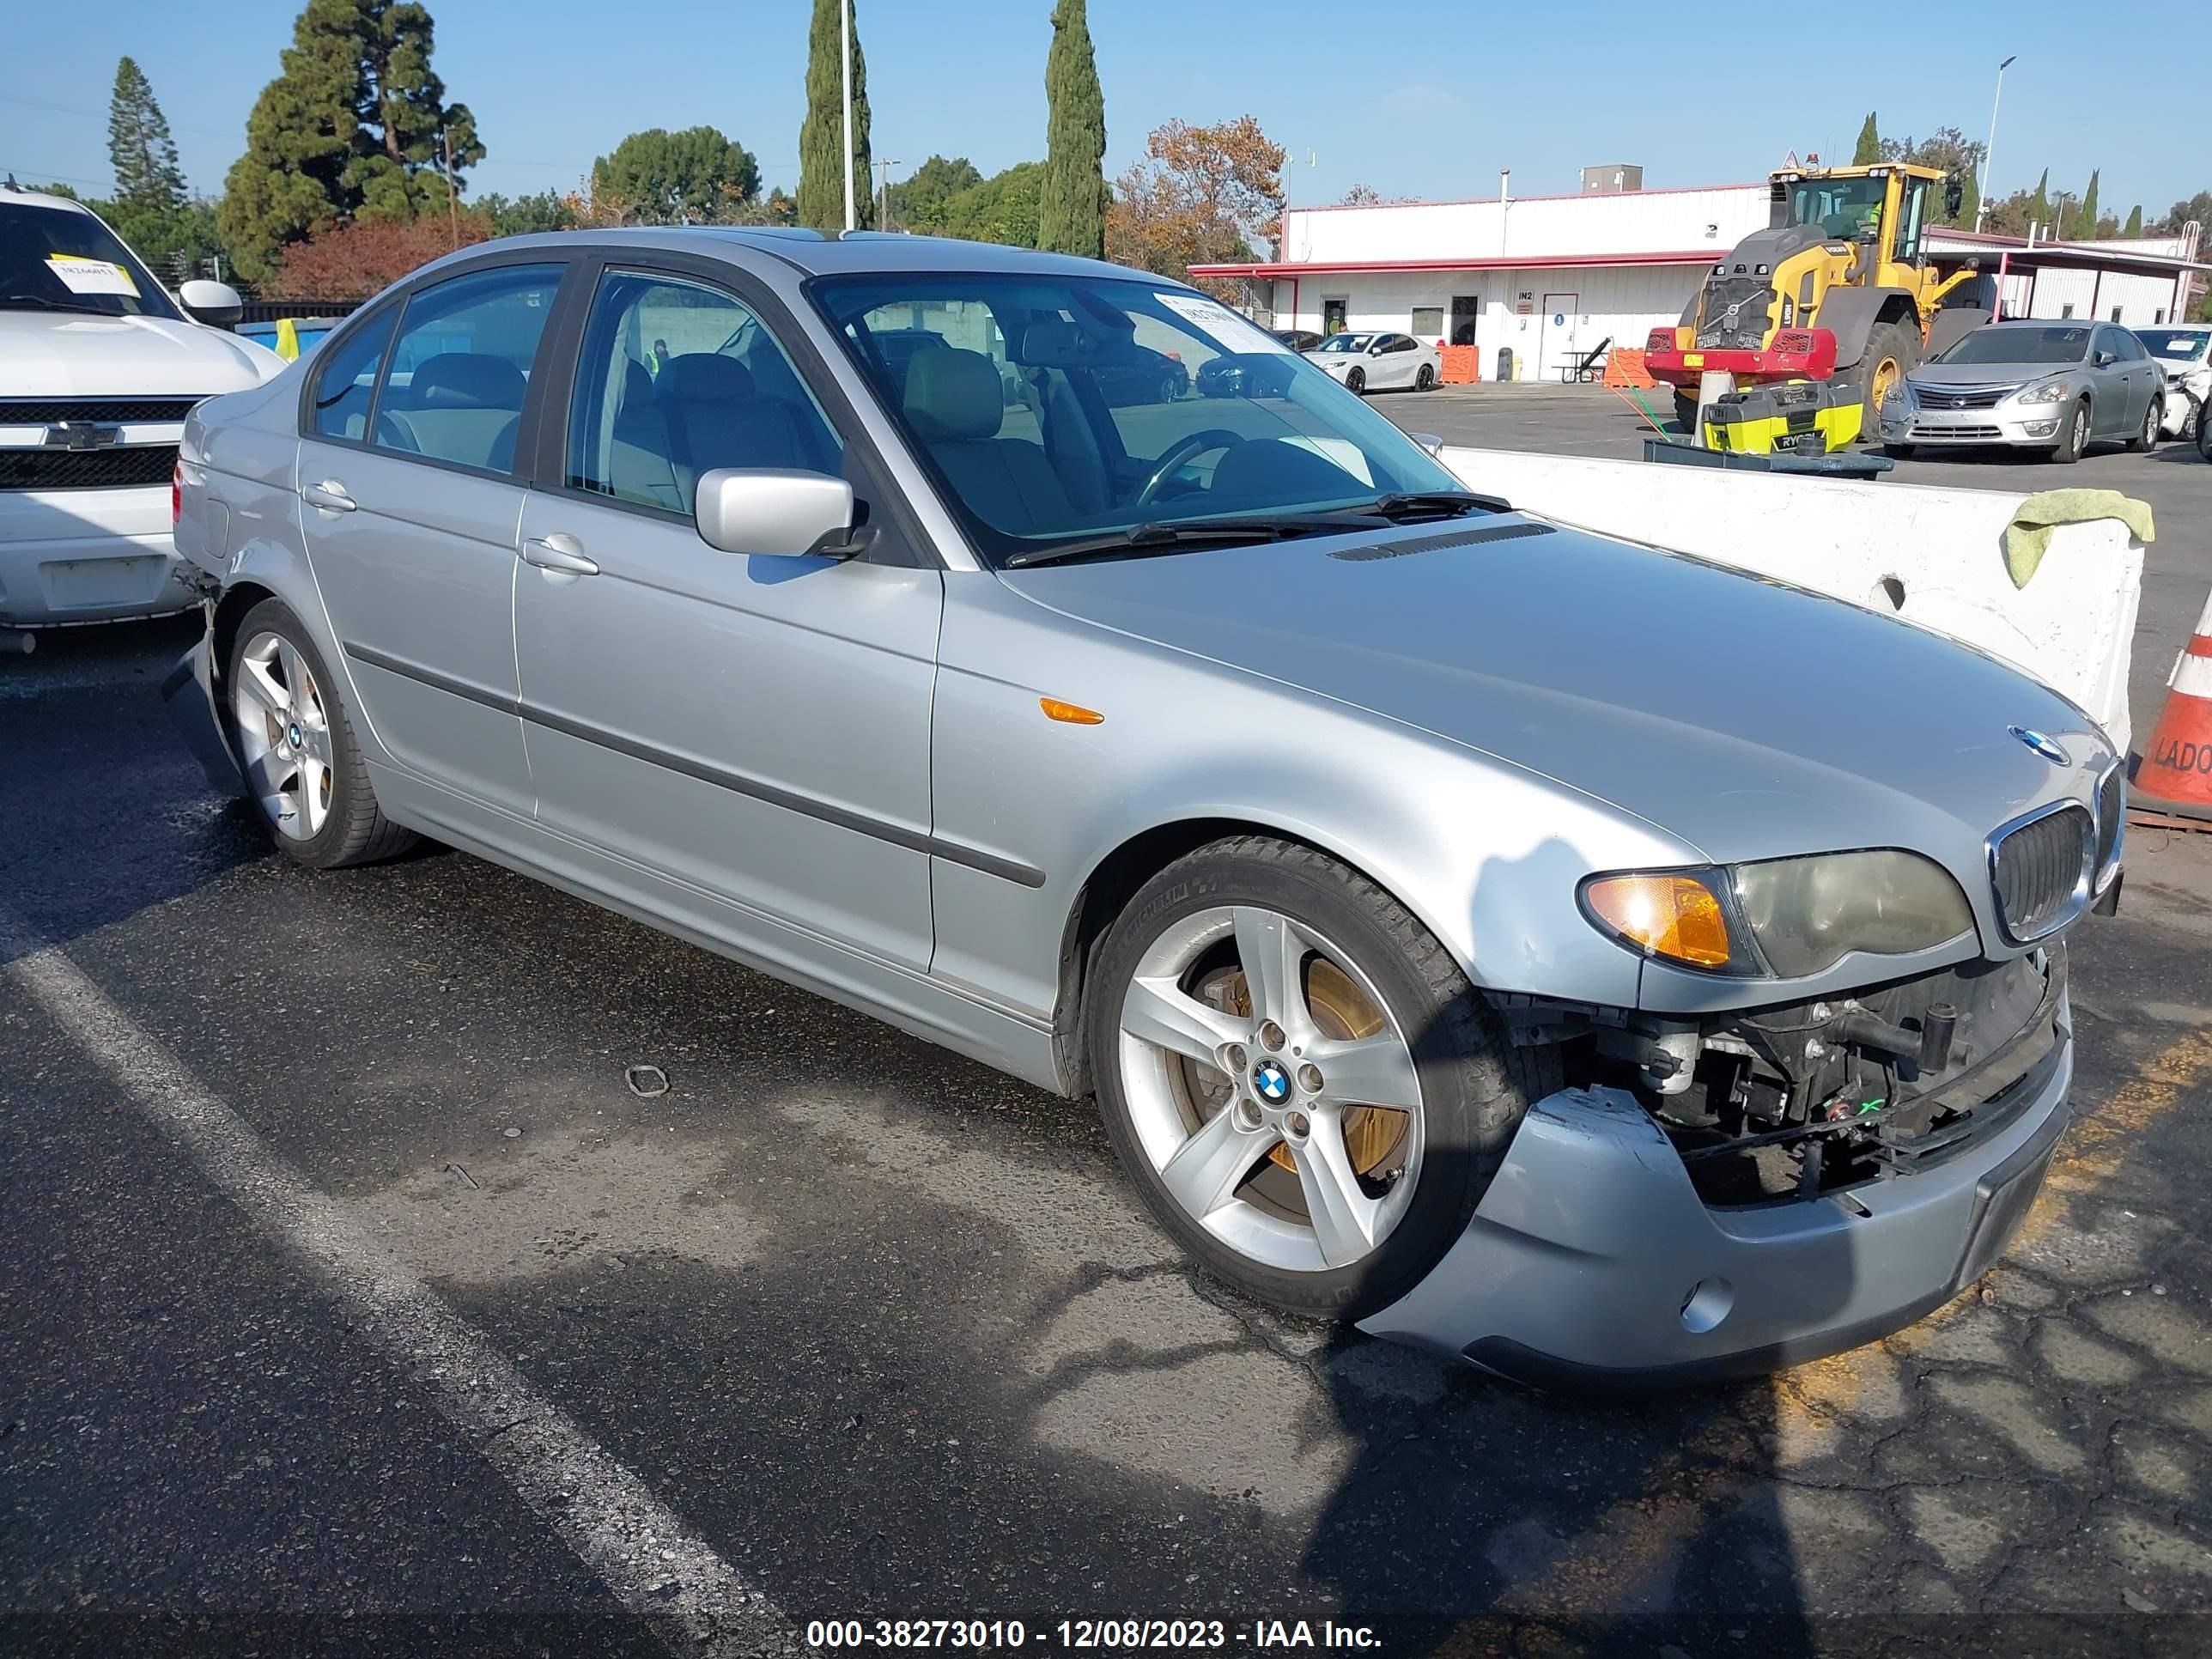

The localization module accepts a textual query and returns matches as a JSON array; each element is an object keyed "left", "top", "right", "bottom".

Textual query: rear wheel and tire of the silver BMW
[{"left": 223, "top": 599, "right": 416, "bottom": 869}]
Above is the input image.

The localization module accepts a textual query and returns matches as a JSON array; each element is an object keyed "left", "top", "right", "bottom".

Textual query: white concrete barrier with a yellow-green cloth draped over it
[{"left": 1443, "top": 447, "right": 2143, "bottom": 754}]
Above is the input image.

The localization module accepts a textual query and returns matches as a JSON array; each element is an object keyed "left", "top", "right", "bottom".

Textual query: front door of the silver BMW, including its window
[{"left": 514, "top": 265, "right": 942, "bottom": 971}]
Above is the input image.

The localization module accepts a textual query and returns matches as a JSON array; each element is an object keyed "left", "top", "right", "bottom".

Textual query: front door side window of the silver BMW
[{"left": 566, "top": 272, "right": 840, "bottom": 514}]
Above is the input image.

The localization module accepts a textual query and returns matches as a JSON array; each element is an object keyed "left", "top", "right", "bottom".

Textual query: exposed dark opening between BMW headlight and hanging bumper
[{"left": 1493, "top": 945, "right": 2066, "bottom": 1206}]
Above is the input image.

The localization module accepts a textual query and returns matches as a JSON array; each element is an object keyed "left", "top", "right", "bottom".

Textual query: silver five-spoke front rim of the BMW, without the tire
[{"left": 1119, "top": 905, "right": 1422, "bottom": 1272}]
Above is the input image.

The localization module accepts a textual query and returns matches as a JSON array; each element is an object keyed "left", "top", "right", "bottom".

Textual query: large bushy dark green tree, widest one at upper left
[{"left": 222, "top": 0, "right": 484, "bottom": 281}]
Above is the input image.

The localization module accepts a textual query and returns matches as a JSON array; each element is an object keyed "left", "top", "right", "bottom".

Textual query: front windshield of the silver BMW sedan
[{"left": 807, "top": 272, "right": 1464, "bottom": 562}]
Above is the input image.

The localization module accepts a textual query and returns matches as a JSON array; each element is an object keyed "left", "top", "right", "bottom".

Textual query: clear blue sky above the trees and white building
[{"left": 0, "top": 0, "right": 2176, "bottom": 215}]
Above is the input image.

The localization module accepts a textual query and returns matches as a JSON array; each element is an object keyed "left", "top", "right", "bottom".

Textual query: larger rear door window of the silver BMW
[{"left": 374, "top": 265, "right": 562, "bottom": 473}]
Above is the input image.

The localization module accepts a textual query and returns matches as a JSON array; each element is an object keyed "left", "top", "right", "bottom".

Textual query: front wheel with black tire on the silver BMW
[{"left": 1084, "top": 836, "right": 1558, "bottom": 1318}]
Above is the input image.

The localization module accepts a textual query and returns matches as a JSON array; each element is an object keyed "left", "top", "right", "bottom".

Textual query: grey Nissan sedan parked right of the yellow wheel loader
[{"left": 1881, "top": 321, "right": 2166, "bottom": 462}]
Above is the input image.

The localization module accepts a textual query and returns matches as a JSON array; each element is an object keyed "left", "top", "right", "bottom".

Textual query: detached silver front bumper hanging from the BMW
[{"left": 1360, "top": 967, "right": 2073, "bottom": 1391}]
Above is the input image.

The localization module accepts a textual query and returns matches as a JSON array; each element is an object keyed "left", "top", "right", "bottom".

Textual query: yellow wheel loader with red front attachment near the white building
[{"left": 1644, "top": 161, "right": 1989, "bottom": 444}]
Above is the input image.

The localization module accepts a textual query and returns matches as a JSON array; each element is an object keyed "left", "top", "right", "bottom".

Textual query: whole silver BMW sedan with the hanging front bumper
[{"left": 168, "top": 230, "right": 2124, "bottom": 1385}]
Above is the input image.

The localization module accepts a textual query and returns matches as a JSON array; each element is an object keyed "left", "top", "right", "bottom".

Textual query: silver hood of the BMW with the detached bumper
[{"left": 1005, "top": 515, "right": 2106, "bottom": 862}]
